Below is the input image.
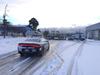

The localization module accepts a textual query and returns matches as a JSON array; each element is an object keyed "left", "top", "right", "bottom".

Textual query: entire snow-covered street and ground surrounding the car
[{"left": 0, "top": 38, "right": 100, "bottom": 75}]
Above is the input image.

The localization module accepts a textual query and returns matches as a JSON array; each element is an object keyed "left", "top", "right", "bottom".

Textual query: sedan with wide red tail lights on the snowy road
[{"left": 18, "top": 37, "right": 49, "bottom": 56}]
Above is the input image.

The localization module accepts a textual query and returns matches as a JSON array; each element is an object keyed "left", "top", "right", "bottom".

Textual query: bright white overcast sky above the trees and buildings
[{"left": 0, "top": 0, "right": 100, "bottom": 27}]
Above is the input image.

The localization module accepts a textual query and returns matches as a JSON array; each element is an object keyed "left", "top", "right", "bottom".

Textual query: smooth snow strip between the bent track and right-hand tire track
[{"left": 56, "top": 43, "right": 80, "bottom": 75}]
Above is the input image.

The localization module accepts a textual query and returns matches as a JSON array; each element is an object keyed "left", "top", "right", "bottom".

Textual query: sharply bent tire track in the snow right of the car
[{"left": 46, "top": 41, "right": 79, "bottom": 75}]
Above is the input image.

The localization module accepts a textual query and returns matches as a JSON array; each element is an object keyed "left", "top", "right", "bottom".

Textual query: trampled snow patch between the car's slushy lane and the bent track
[{"left": 33, "top": 55, "right": 63, "bottom": 75}]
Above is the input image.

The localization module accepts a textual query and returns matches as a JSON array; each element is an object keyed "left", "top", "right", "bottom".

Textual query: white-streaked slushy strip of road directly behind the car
[{"left": 10, "top": 58, "right": 40, "bottom": 75}]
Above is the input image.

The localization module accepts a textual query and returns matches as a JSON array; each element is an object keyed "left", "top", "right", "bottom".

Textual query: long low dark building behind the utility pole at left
[{"left": 0, "top": 25, "right": 32, "bottom": 36}]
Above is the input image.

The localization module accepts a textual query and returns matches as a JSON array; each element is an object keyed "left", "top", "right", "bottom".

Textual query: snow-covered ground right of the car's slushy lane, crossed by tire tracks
[{"left": 33, "top": 40, "right": 100, "bottom": 75}]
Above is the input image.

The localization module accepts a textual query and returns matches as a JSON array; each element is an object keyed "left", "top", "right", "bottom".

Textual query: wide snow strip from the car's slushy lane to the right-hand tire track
[{"left": 33, "top": 41, "right": 80, "bottom": 75}]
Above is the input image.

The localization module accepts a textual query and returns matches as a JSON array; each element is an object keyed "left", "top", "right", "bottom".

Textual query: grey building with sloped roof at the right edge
[{"left": 86, "top": 23, "right": 100, "bottom": 40}]
